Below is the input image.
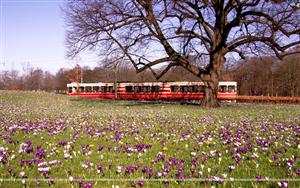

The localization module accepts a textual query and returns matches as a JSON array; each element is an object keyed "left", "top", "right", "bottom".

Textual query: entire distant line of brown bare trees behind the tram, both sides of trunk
[{"left": 0, "top": 55, "right": 300, "bottom": 96}]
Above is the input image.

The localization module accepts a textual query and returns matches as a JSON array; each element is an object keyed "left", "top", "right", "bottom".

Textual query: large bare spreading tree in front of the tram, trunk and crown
[{"left": 65, "top": 0, "right": 300, "bottom": 107}]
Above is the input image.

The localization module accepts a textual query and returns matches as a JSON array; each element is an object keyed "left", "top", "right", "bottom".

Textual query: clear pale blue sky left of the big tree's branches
[{"left": 0, "top": 0, "right": 97, "bottom": 73}]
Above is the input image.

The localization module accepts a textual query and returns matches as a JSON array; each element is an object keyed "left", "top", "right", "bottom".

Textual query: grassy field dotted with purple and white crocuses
[{"left": 0, "top": 92, "right": 300, "bottom": 187}]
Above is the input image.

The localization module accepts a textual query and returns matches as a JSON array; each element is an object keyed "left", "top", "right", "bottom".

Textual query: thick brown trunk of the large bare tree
[{"left": 201, "top": 50, "right": 225, "bottom": 107}]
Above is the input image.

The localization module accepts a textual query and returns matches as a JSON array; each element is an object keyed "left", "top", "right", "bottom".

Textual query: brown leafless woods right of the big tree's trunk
[{"left": 228, "top": 55, "right": 300, "bottom": 97}]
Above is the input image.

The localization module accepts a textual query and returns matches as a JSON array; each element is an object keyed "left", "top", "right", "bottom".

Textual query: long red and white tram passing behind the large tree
[{"left": 67, "top": 82, "right": 237, "bottom": 101}]
